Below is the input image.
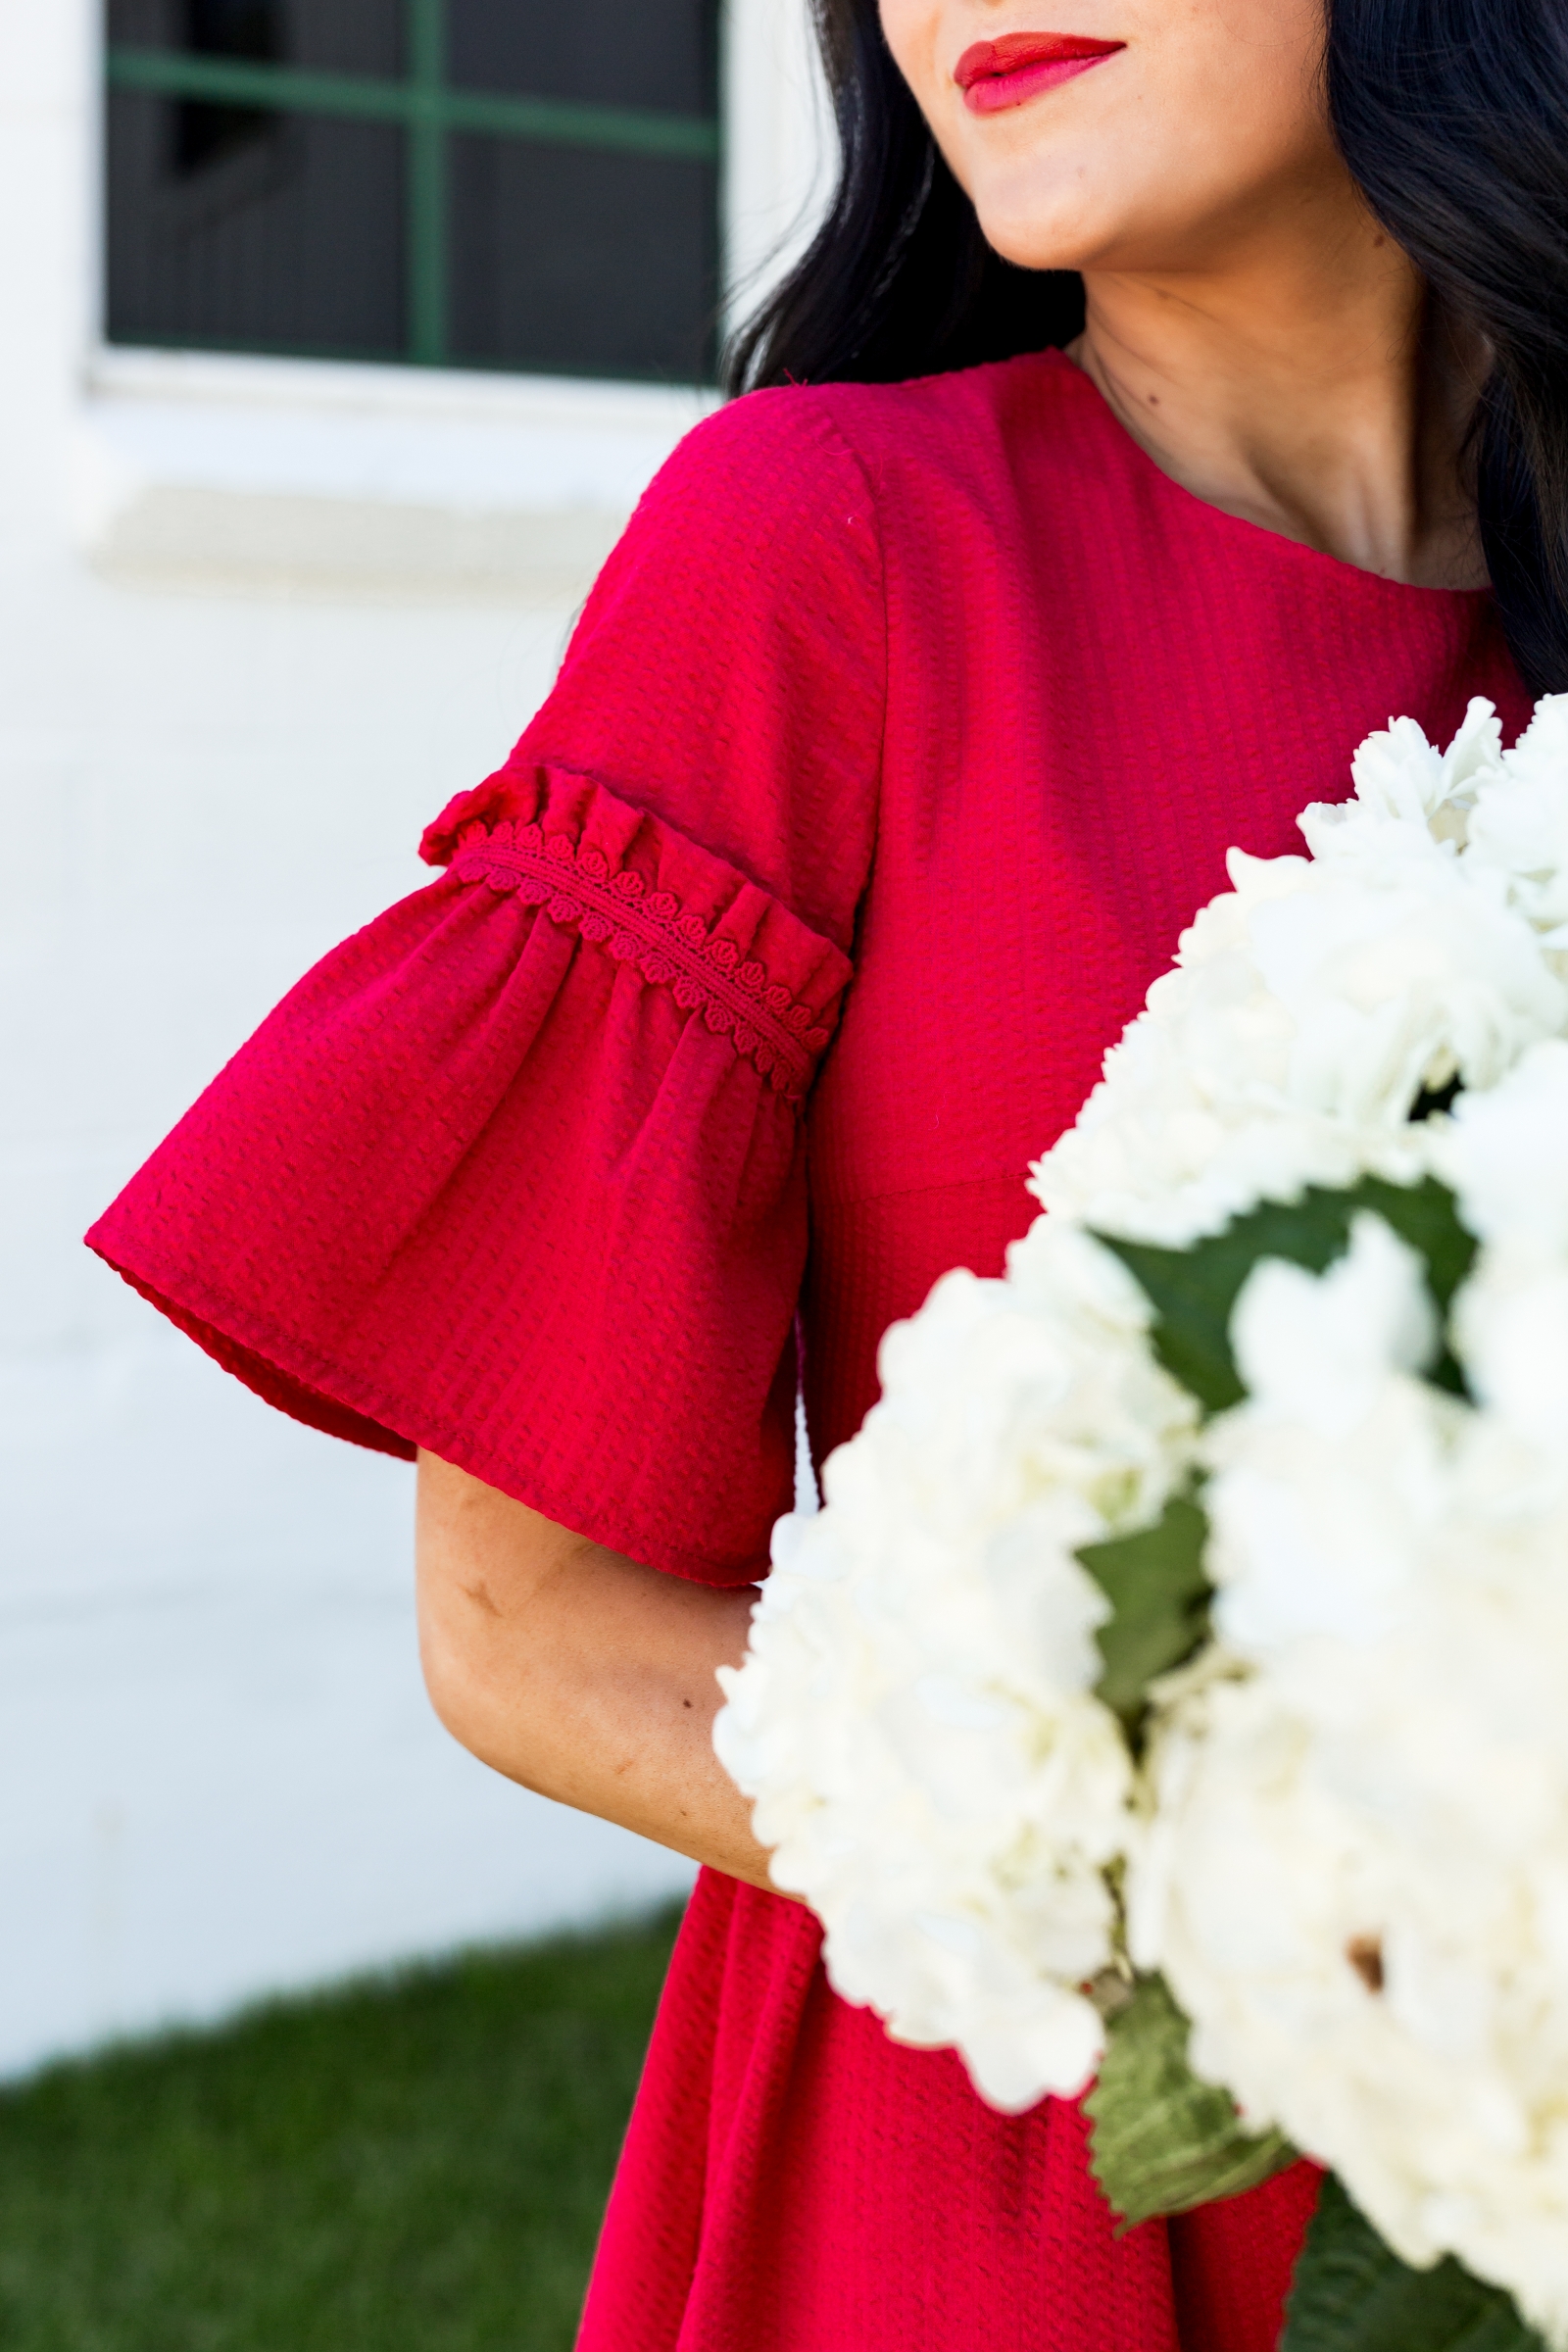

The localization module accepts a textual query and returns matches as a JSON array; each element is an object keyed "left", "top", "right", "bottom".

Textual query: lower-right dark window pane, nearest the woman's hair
[{"left": 452, "top": 139, "right": 717, "bottom": 383}]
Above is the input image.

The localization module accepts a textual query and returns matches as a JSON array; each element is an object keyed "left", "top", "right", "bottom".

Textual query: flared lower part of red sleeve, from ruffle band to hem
[{"left": 89, "top": 766, "right": 849, "bottom": 1583}]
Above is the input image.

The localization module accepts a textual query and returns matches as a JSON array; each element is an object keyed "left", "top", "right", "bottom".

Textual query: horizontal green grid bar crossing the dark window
[{"left": 108, "top": 45, "right": 719, "bottom": 163}]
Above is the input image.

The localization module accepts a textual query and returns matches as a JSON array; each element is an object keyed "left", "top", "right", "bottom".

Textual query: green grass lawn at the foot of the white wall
[{"left": 0, "top": 1915, "right": 674, "bottom": 2352}]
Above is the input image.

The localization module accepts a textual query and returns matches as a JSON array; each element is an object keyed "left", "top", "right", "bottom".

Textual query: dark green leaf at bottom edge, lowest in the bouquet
[{"left": 1279, "top": 2178, "right": 1546, "bottom": 2352}]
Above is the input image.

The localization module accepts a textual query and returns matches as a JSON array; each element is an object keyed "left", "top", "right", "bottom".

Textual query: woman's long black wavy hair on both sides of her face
[{"left": 726, "top": 0, "right": 1568, "bottom": 694}]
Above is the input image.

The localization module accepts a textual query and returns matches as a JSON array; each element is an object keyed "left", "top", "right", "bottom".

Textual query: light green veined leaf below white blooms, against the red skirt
[{"left": 1084, "top": 1976, "right": 1296, "bottom": 2228}]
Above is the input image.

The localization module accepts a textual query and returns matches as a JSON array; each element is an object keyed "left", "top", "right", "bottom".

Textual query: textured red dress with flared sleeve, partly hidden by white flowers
[{"left": 92, "top": 355, "right": 1526, "bottom": 2352}]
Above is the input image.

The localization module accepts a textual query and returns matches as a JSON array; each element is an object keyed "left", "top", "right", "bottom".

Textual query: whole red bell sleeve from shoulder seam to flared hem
[{"left": 87, "top": 395, "right": 884, "bottom": 1583}]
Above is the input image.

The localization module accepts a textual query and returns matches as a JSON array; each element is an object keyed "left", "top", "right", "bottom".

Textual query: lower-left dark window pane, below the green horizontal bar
[{"left": 108, "top": 92, "right": 405, "bottom": 360}]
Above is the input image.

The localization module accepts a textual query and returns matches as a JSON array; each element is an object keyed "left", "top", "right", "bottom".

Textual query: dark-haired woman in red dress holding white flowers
[{"left": 94, "top": 0, "right": 1568, "bottom": 2352}]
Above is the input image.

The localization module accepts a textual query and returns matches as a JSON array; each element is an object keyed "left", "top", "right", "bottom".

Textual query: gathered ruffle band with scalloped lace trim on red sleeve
[{"left": 420, "top": 769, "right": 849, "bottom": 1103}]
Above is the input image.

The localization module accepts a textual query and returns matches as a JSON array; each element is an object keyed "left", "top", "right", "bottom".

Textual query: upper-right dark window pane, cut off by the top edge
[{"left": 447, "top": 0, "right": 719, "bottom": 116}]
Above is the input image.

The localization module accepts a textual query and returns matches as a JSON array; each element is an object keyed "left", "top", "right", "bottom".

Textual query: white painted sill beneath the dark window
[{"left": 75, "top": 351, "right": 717, "bottom": 605}]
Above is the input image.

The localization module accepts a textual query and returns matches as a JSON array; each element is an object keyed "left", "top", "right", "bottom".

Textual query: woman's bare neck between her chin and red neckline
[{"left": 1072, "top": 200, "right": 1486, "bottom": 588}]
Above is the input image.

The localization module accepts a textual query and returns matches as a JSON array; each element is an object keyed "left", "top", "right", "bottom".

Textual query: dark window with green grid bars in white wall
[{"left": 108, "top": 0, "right": 719, "bottom": 383}]
